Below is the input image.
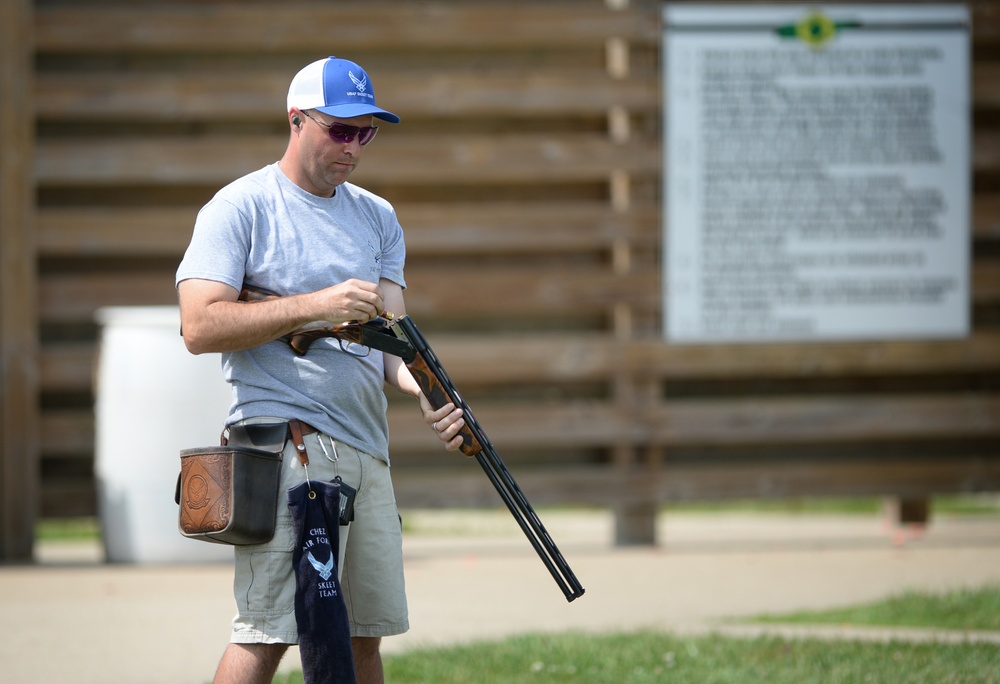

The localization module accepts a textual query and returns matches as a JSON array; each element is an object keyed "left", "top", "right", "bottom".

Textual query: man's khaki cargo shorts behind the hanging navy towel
[{"left": 230, "top": 419, "right": 409, "bottom": 644}]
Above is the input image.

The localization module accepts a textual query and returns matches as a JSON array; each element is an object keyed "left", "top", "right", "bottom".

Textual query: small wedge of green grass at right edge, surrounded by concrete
[{"left": 755, "top": 587, "right": 1000, "bottom": 632}]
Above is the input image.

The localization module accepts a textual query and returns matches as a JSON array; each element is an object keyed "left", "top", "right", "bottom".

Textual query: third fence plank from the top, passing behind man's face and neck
[{"left": 35, "top": 133, "right": 660, "bottom": 187}]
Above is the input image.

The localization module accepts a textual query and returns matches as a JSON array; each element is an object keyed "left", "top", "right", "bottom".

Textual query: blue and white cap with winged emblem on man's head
[{"left": 287, "top": 57, "right": 399, "bottom": 123}]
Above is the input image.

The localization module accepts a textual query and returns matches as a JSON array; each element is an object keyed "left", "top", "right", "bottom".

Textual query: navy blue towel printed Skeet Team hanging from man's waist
[{"left": 288, "top": 482, "right": 356, "bottom": 684}]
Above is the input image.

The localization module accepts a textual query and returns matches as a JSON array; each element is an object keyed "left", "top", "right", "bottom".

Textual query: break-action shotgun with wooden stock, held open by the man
[{"left": 240, "top": 288, "right": 584, "bottom": 601}]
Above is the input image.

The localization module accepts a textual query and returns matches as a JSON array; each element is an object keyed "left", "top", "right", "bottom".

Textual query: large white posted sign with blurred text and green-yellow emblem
[{"left": 663, "top": 5, "right": 971, "bottom": 343}]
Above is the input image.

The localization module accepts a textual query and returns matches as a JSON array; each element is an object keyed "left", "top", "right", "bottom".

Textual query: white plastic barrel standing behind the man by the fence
[{"left": 95, "top": 306, "right": 233, "bottom": 563}]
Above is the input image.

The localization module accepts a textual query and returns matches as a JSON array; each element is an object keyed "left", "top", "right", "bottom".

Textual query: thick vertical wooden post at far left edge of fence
[{"left": 0, "top": 0, "right": 40, "bottom": 561}]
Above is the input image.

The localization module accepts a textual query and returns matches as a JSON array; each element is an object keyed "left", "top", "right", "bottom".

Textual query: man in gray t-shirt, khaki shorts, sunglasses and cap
[{"left": 177, "top": 57, "right": 464, "bottom": 684}]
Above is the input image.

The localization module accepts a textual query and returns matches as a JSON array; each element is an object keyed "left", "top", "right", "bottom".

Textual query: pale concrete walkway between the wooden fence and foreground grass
[{"left": 0, "top": 511, "right": 1000, "bottom": 684}]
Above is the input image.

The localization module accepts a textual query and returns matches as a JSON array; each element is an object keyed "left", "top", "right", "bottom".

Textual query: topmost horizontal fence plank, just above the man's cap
[{"left": 35, "top": 0, "right": 659, "bottom": 54}]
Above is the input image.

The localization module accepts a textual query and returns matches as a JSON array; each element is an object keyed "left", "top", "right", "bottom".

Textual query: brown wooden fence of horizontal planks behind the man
[{"left": 0, "top": 0, "right": 1000, "bottom": 556}]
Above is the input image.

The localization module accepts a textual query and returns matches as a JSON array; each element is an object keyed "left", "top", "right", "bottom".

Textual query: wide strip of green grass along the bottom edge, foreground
[{"left": 386, "top": 632, "right": 1000, "bottom": 684}]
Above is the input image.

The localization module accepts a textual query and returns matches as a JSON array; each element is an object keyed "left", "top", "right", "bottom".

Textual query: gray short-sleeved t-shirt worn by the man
[{"left": 176, "top": 164, "right": 406, "bottom": 462}]
